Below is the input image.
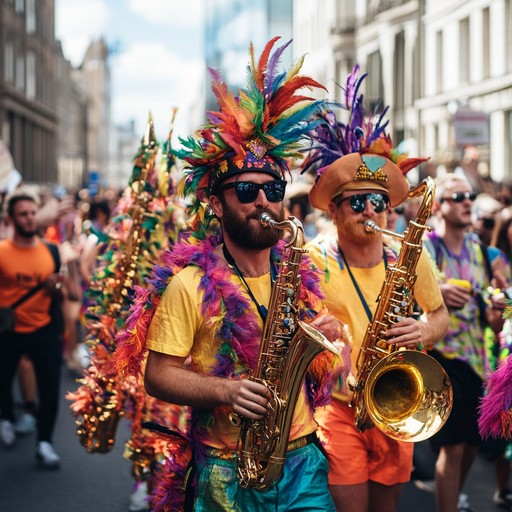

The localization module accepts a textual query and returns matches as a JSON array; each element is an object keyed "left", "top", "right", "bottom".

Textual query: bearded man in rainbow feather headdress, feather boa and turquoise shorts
[{"left": 138, "top": 38, "right": 350, "bottom": 512}]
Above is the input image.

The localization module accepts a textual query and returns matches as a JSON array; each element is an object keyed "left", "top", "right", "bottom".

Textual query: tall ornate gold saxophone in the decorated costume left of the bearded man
[{"left": 68, "top": 115, "right": 158, "bottom": 453}]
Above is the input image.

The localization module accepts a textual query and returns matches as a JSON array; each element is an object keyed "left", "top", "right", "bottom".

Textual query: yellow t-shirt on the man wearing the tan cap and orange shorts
[{"left": 307, "top": 234, "right": 443, "bottom": 400}]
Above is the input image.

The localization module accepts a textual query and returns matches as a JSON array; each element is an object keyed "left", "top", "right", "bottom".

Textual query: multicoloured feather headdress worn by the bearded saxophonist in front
[{"left": 175, "top": 37, "right": 325, "bottom": 236}]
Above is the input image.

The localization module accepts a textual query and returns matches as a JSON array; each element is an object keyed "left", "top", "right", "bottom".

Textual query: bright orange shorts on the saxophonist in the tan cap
[{"left": 315, "top": 399, "right": 414, "bottom": 485}]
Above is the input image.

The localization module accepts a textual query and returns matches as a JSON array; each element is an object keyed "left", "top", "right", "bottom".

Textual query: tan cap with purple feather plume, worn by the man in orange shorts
[{"left": 302, "top": 65, "right": 427, "bottom": 211}]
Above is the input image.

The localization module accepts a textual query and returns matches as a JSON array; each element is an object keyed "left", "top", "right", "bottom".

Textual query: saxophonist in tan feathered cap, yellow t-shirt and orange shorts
[{"left": 307, "top": 67, "right": 448, "bottom": 512}]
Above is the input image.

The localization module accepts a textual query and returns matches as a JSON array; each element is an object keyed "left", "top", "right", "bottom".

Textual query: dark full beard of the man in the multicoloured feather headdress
[{"left": 222, "top": 202, "right": 284, "bottom": 250}]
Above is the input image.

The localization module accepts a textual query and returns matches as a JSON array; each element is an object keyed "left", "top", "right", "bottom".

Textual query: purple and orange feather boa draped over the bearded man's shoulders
[{"left": 112, "top": 236, "right": 337, "bottom": 511}]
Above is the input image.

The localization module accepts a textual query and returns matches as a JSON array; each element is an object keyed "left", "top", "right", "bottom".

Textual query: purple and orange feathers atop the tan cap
[{"left": 302, "top": 65, "right": 427, "bottom": 175}]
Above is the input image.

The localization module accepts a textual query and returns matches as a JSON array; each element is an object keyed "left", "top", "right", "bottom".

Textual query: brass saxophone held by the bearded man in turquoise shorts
[{"left": 231, "top": 213, "right": 338, "bottom": 491}]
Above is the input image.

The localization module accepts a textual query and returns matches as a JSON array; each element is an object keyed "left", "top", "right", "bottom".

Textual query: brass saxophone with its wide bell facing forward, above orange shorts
[{"left": 350, "top": 177, "right": 453, "bottom": 442}]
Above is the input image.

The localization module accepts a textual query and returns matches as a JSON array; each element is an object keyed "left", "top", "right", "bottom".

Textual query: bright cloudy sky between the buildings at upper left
[{"left": 55, "top": 0, "right": 205, "bottom": 139}]
